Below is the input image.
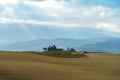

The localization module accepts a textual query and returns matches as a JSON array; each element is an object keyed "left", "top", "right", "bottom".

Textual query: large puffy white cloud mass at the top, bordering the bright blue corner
[{"left": 24, "top": 0, "right": 117, "bottom": 19}]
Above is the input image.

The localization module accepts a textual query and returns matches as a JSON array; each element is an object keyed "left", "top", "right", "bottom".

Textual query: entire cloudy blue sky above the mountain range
[{"left": 0, "top": 0, "right": 120, "bottom": 45}]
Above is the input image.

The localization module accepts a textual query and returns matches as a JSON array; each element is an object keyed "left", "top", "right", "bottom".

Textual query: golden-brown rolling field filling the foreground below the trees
[{"left": 0, "top": 52, "right": 120, "bottom": 80}]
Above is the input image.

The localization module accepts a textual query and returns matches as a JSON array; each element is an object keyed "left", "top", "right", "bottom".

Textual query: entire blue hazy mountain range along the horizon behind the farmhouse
[{"left": 0, "top": 38, "right": 120, "bottom": 53}]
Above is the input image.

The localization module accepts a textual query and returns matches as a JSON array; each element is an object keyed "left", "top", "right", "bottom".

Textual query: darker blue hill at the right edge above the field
[{"left": 77, "top": 39, "right": 120, "bottom": 53}]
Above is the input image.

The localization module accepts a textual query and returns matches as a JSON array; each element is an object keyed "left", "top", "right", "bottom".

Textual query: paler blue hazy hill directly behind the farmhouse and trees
[{"left": 0, "top": 38, "right": 92, "bottom": 51}]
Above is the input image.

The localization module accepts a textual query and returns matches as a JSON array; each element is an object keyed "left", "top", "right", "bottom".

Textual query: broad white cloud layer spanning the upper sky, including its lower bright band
[{"left": 0, "top": 0, "right": 120, "bottom": 33}]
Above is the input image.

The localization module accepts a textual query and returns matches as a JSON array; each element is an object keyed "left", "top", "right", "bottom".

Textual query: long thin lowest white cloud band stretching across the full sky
[{"left": 0, "top": 17, "right": 120, "bottom": 33}]
